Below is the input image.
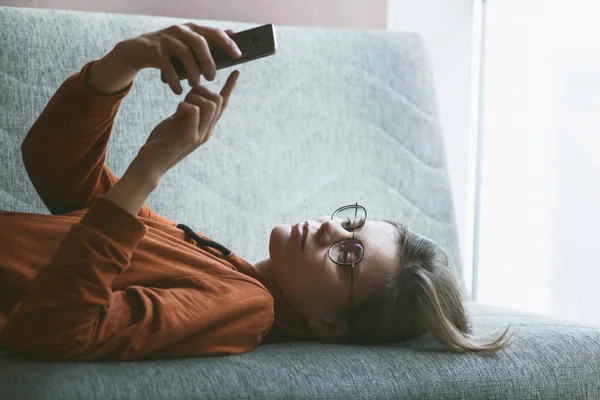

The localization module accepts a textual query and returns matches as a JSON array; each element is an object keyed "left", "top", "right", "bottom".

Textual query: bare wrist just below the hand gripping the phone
[{"left": 85, "top": 44, "right": 139, "bottom": 96}]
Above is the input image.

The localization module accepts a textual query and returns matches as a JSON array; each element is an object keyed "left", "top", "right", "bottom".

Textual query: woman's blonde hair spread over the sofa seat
[{"left": 346, "top": 221, "right": 515, "bottom": 354}]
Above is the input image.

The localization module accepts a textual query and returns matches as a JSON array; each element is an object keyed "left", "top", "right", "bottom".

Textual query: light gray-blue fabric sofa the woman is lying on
[{"left": 0, "top": 7, "right": 600, "bottom": 400}]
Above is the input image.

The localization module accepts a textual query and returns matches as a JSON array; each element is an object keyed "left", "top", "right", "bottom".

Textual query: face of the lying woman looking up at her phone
[{"left": 268, "top": 216, "right": 398, "bottom": 321}]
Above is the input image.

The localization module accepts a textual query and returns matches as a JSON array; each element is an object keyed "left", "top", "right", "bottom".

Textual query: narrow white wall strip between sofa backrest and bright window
[{"left": 387, "top": 0, "right": 473, "bottom": 285}]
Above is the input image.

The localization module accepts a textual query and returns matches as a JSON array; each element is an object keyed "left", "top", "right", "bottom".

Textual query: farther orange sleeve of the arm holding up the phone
[{"left": 21, "top": 60, "right": 169, "bottom": 225}]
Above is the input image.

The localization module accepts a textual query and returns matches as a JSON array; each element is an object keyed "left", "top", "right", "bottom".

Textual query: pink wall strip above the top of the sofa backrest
[{"left": 0, "top": 0, "right": 387, "bottom": 29}]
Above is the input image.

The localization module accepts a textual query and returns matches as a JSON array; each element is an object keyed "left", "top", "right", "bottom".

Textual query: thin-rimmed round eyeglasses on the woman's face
[{"left": 328, "top": 203, "right": 367, "bottom": 307}]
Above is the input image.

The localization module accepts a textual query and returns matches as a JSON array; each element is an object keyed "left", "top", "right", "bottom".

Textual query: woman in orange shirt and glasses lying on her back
[{"left": 0, "top": 23, "right": 509, "bottom": 361}]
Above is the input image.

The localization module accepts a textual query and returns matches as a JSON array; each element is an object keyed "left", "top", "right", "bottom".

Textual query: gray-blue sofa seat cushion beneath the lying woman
[{"left": 0, "top": 304, "right": 600, "bottom": 400}]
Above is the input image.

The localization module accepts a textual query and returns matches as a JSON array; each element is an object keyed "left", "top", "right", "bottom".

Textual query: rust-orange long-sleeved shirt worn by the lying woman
[{"left": 0, "top": 61, "right": 315, "bottom": 360}]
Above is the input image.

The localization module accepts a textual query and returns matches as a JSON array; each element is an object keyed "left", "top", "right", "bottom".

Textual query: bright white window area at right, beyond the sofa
[{"left": 476, "top": 0, "right": 600, "bottom": 325}]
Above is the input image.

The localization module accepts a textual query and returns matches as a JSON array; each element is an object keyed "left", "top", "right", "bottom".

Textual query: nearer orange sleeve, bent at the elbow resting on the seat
[{"left": 0, "top": 196, "right": 273, "bottom": 361}]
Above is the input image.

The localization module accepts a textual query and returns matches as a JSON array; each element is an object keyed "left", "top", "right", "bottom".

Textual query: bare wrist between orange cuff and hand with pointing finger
[{"left": 104, "top": 156, "right": 160, "bottom": 216}]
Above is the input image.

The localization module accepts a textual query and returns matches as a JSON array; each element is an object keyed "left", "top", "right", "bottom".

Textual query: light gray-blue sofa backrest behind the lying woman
[{"left": 0, "top": 7, "right": 464, "bottom": 296}]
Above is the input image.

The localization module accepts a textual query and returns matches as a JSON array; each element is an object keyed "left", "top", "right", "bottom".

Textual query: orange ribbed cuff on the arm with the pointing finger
[{"left": 79, "top": 196, "right": 148, "bottom": 249}]
